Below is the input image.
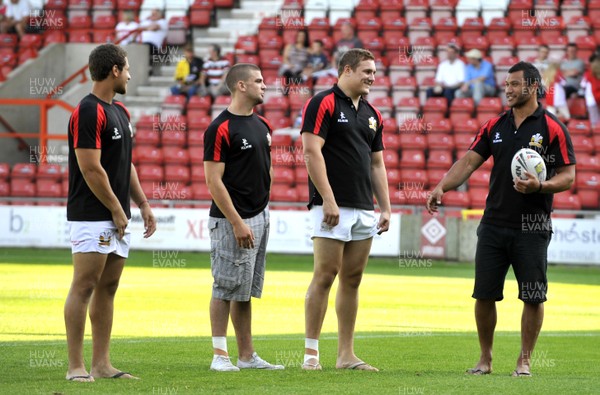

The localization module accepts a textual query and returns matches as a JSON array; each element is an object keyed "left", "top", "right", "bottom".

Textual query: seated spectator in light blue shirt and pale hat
[{"left": 454, "top": 49, "right": 496, "bottom": 105}]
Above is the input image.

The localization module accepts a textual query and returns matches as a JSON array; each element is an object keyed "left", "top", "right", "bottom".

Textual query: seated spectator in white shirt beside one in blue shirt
[{"left": 427, "top": 44, "right": 465, "bottom": 105}]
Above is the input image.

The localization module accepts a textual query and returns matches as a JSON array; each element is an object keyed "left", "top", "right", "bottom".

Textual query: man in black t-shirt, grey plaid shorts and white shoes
[{"left": 204, "top": 63, "right": 284, "bottom": 372}]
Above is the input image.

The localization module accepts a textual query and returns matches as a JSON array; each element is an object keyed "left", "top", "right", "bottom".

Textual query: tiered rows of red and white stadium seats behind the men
[{"left": 0, "top": 0, "right": 600, "bottom": 210}]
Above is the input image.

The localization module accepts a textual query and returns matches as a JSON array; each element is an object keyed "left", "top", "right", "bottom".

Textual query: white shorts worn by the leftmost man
[{"left": 68, "top": 221, "right": 131, "bottom": 258}]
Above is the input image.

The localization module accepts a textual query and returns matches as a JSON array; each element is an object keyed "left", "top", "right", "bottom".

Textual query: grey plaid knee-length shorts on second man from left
[{"left": 208, "top": 208, "right": 269, "bottom": 302}]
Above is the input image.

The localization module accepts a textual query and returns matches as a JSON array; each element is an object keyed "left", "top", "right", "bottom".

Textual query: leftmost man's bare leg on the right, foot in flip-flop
[{"left": 90, "top": 254, "right": 133, "bottom": 379}]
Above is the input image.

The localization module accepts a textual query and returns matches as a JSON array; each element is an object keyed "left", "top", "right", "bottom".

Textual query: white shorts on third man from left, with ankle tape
[{"left": 310, "top": 206, "right": 378, "bottom": 241}]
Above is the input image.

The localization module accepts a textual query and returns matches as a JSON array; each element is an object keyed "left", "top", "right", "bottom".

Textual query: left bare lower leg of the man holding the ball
[{"left": 468, "top": 299, "right": 497, "bottom": 374}]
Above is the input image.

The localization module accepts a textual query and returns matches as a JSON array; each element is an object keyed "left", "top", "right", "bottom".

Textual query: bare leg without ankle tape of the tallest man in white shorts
[{"left": 335, "top": 238, "right": 373, "bottom": 368}]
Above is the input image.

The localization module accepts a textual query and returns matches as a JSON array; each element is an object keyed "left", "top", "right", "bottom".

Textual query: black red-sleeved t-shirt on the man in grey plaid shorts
[{"left": 204, "top": 110, "right": 272, "bottom": 218}]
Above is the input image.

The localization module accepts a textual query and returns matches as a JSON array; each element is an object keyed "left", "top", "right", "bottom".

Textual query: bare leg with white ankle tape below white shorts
[{"left": 304, "top": 237, "right": 344, "bottom": 363}]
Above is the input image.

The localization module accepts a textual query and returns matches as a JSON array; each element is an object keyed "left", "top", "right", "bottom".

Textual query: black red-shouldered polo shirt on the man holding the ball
[{"left": 469, "top": 103, "right": 575, "bottom": 229}]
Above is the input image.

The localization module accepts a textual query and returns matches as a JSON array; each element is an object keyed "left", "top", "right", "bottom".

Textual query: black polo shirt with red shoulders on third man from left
[{"left": 300, "top": 85, "right": 384, "bottom": 210}]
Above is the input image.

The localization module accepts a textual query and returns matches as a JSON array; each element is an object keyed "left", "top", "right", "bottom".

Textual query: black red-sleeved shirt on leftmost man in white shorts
[{"left": 67, "top": 93, "right": 133, "bottom": 221}]
